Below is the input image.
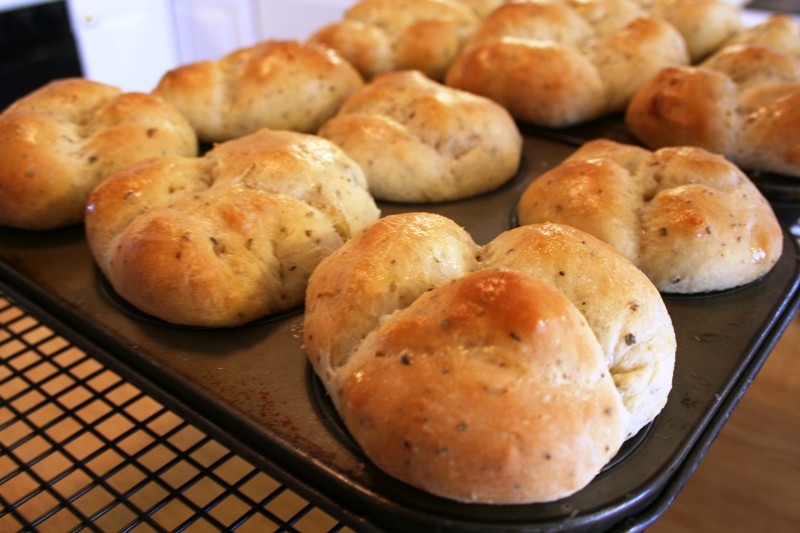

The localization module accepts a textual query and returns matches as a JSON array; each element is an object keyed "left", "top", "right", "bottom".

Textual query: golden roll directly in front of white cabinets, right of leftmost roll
[{"left": 153, "top": 40, "right": 364, "bottom": 142}]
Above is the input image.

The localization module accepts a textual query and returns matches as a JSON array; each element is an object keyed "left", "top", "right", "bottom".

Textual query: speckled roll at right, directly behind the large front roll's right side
[{"left": 518, "top": 139, "right": 783, "bottom": 294}]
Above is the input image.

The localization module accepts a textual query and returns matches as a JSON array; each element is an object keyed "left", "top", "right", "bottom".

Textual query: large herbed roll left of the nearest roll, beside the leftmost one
[{"left": 86, "top": 130, "right": 380, "bottom": 327}]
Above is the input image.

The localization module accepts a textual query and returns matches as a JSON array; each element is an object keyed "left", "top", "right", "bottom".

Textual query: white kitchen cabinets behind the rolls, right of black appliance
[{"left": 67, "top": 0, "right": 355, "bottom": 92}]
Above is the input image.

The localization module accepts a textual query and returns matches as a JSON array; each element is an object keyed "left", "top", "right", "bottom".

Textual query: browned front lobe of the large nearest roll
[{"left": 341, "top": 269, "right": 624, "bottom": 503}]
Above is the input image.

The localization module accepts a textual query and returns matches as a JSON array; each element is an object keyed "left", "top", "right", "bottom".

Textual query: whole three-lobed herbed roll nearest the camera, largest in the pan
[{"left": 304, "top": 213, "right": 676, "bottom": 504}]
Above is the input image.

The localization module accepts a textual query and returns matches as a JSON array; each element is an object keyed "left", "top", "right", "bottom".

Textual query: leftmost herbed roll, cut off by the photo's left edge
[{"left": 0, "top": 78, "right": 198, "bottom": 230}]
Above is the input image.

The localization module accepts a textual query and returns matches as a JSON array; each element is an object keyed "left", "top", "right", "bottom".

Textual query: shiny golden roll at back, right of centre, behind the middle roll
[{"left": 445, "top": 0, "right": 689, "bottom": 128}]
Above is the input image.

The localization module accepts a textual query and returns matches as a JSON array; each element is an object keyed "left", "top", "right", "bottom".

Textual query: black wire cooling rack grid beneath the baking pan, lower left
[{"left": 0, "top": 293, "right": 349, "bottom": 533}]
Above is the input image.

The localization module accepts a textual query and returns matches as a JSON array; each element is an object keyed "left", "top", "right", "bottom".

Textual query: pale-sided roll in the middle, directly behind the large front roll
[{"left": 319, "top": 71, "right": 522, "bottom": 202}]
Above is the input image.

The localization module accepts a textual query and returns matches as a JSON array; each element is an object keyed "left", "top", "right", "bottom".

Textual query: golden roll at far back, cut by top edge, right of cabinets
[{"left": 309, "top": 0, "right": 480, "bottom": 81}]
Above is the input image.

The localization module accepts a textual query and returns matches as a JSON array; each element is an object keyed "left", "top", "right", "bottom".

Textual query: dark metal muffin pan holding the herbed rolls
[{"left": 0, "top": 131, "right": 800, "bottom": 532}]
